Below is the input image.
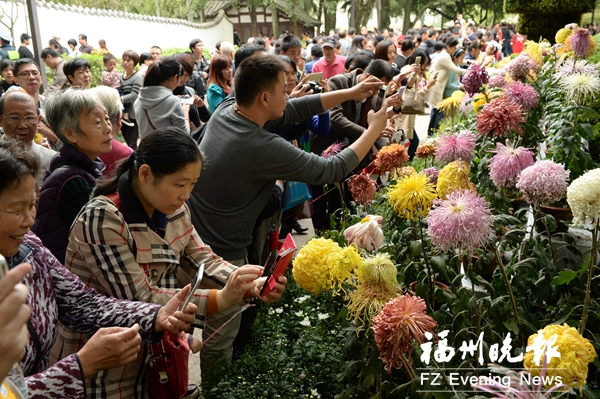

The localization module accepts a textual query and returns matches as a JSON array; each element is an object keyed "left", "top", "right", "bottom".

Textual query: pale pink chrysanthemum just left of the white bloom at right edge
[{"left": 517, "top": 160, "right": 569, "bottom": 204}]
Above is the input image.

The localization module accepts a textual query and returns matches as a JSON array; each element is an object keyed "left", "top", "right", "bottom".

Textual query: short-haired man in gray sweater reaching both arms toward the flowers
[{"left": 189, "top": 55, "right": 387, "bottom": 373}]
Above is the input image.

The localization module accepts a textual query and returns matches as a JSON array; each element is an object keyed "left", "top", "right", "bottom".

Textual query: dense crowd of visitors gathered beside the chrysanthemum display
[{"left": 0, "top": 15, "right": 596, "bottom": 398}]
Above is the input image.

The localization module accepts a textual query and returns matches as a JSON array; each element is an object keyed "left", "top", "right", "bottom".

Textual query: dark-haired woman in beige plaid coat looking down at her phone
[{"left": 55, "top": 127, "right": 285, "bottom": 398}]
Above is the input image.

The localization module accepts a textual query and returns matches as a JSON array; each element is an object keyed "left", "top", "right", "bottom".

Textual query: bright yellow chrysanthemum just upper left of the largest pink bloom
[{"left": 388, "top": 173, "right": 436, "bottom": 220}]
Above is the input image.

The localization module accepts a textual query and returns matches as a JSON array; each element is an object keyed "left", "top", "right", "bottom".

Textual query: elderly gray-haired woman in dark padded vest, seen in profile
[{"left": 33, "top": 89, "right": 112, "bottom": 262}]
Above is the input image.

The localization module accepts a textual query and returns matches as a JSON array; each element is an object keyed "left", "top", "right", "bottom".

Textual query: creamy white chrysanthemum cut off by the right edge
[{"left": 567, "top": 169, "right": 600, "bottom": 224}]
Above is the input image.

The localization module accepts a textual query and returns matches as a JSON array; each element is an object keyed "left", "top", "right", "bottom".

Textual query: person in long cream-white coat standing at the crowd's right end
[{"left": 427, "top": 37, "right": 466, "bottom": 136}]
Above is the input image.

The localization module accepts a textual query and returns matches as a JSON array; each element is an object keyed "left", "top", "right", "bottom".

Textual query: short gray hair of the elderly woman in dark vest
[{"left": 44, "top": 88, "right": 102, "bottom": 145}]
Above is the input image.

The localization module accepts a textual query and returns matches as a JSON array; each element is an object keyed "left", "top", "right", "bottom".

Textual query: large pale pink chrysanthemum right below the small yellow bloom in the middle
[{"left": 427, "top": 190, "right": 494, "bottom": 253}]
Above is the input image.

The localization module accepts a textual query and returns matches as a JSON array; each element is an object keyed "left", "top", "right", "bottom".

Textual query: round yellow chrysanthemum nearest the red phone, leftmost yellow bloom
[{"left": 292, "top": 238, "right": 341, "bottom": 296}]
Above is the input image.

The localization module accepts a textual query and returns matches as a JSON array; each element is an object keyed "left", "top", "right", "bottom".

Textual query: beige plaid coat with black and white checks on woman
[{"left": 53, "top": 174, "right": 236, "bottom": 398}]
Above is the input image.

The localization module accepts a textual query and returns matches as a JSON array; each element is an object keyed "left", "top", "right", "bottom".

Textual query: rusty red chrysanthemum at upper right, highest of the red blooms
[{"left": 476, "top": 96, "right": 525, "bottom": 137}]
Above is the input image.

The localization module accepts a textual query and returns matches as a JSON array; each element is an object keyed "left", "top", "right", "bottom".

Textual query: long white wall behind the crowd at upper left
[{"left": 0, "top": 0, "right": 233, "bottom": 58}]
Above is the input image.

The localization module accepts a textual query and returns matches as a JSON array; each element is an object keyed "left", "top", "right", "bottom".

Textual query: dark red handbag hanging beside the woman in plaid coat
[{"left": 148, "top": 331, "right": 190, "bottom": 399}]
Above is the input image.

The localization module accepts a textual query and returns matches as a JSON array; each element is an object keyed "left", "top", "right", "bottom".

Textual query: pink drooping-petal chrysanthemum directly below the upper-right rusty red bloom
[{"left": 490, "top": 140, "right": 533, "bottom": 189}]
